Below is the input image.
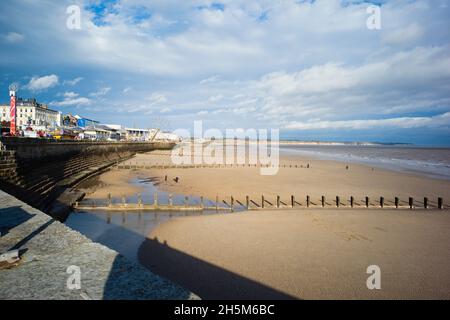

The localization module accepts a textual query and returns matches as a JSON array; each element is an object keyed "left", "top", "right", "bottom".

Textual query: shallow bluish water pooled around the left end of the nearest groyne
[{"left": 65, "top": 178, "right": 243, "bottom": 261}]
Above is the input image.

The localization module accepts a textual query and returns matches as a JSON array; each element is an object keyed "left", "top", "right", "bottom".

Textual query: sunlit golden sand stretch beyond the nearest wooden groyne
[{"left": 88, "top": 152, "right": 450, "bottom": 202}]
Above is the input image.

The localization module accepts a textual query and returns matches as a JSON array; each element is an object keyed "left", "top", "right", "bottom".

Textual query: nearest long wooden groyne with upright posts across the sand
[{"left": 74, "top": 194, "right": 448, "bottom": 212}]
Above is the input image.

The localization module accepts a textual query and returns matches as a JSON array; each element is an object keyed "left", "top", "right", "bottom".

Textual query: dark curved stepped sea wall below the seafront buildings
[{"left": 0, "top": 138, "right": 175, "bottom": 221}]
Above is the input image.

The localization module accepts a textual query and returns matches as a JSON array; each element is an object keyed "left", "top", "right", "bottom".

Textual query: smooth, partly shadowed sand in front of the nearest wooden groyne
[{"left": 139, "top": 210, "right": 450, "bottom": 299}]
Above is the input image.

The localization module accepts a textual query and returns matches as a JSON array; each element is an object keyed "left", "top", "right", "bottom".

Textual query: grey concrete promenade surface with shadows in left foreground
[{"left": 0, "top": 191, "right": 198, "bottom": 300}]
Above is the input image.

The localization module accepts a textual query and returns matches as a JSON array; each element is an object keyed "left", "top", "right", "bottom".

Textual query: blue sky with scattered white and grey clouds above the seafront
[{"left": 0, "top": 0, "right": 450, "bottom": 146}]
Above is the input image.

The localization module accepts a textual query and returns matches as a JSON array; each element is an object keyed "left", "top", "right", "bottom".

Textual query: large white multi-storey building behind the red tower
[{"left": 0, "top": 98, "right": 61, "bottom": 127}]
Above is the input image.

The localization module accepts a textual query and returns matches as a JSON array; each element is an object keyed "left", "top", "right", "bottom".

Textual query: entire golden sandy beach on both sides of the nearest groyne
[{"left": 80, "top": 153, "right": 450, "bottom": 299}]
